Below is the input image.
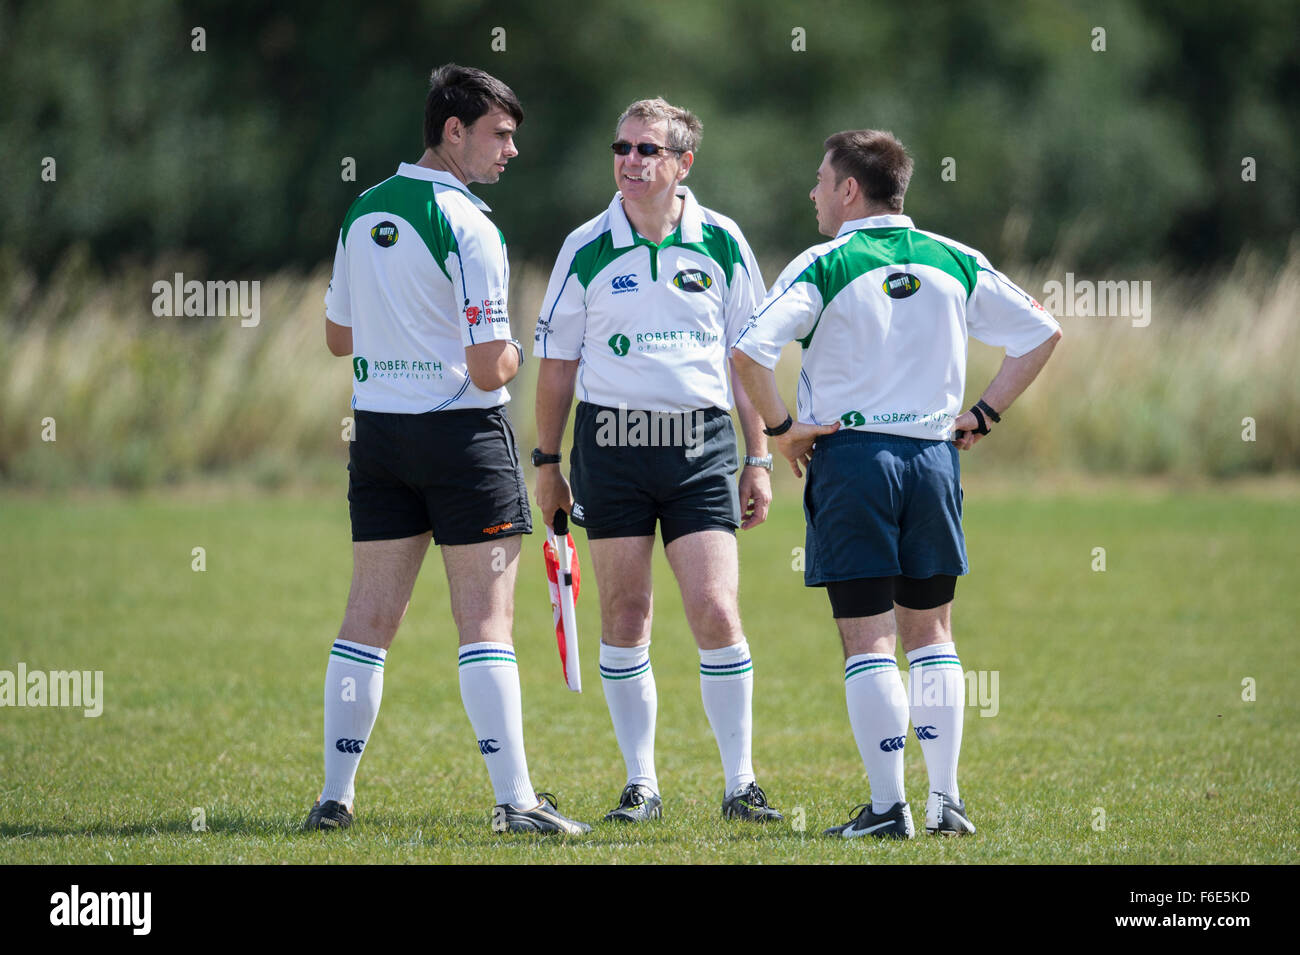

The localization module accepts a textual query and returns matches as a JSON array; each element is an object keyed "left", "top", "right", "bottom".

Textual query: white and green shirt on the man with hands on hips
[{"left": 733, "top": 216, "right": 1061, "bottom": 440}]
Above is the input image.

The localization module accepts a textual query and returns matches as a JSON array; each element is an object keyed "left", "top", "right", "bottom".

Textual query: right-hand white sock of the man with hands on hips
[{"left": 907, "top": 642, "right": 966, "bottom": 799}]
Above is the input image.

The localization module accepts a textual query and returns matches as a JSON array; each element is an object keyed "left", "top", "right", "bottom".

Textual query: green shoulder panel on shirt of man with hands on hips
[{"left": 794, "top": 226, "right": 979, "bottom": 348}]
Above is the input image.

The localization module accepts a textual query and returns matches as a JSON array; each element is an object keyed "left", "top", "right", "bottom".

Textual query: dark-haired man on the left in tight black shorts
[{"left": 306, "top": 64, "right": 589, "bottom": 833}]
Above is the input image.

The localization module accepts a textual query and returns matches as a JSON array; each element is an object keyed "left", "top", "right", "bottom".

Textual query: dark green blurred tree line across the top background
[{"left": 0, "top": 0, "right": 1300, "bottom": 279}]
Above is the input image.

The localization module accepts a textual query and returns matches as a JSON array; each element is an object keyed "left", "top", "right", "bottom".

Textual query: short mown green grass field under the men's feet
[{"left": 0, "top": 485, "right": 1300, "bottom": 864}]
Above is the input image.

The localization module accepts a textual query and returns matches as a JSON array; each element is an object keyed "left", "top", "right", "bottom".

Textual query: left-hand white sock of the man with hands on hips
[{"left": 844, "top": 654, "right": 907, "bottom": 812}]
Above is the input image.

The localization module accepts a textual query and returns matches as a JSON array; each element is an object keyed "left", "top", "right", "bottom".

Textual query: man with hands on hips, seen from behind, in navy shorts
[{"left": 733, "top": 130, "right": 1061, "bottom": 838}]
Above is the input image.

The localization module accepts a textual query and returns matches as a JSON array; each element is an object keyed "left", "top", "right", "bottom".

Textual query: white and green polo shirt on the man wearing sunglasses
[{"left": 533, "top": 187, "right": 763, "bottom": 412}]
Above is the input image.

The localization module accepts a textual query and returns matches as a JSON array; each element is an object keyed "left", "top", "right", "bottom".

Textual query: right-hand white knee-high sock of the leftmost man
[{"left": 459, "top": 643, "right": 537, "bottom": 809}]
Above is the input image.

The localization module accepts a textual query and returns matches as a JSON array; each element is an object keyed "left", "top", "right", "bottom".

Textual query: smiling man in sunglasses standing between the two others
[{"left": 533, "top": 99, "right": 781, "bottom": 822}]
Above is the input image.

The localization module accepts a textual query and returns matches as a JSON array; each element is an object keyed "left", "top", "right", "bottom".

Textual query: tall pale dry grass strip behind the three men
[{"left": 0, "top": 246, "right": 1300, "bottom": 489}]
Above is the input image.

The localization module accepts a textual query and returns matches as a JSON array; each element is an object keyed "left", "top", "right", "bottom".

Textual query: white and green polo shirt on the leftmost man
[{"left": 325, "top": 162, "right": 511, "bottom": 414}]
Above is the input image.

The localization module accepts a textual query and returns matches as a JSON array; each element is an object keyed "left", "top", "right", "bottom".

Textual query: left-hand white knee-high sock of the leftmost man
[{"left": 321, "top": 641, "right": 387, "bottom": 807}]
